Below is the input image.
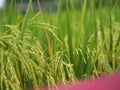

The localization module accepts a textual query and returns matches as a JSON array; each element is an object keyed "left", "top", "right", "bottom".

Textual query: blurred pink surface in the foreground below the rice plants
[{"left": 31, "top": 72, "right": 120, "bottom": 90}]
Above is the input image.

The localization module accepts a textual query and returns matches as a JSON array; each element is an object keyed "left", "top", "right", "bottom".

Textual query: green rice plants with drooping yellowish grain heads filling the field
[{"left": 0, "top": 0, "right": 120, "bottom": 90}]
